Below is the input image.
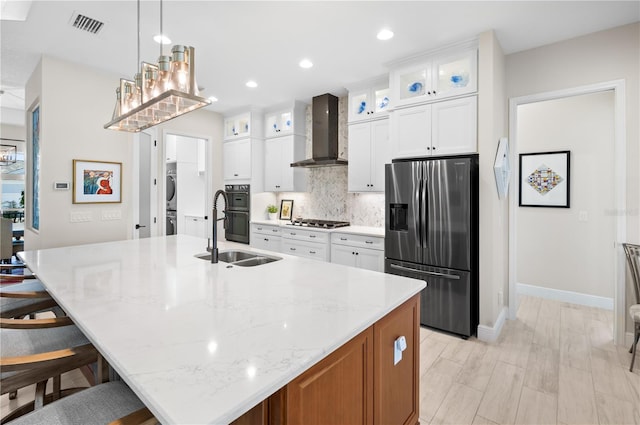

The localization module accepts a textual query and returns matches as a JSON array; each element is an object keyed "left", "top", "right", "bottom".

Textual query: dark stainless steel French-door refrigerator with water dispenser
[{"left": 385, "top": 155, "right": 478, "bottom": 338}]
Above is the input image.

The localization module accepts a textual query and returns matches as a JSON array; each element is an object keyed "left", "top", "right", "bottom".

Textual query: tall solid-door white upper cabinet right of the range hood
[{"left": 348, "top": 119, "right": 391, "bottom": 192}]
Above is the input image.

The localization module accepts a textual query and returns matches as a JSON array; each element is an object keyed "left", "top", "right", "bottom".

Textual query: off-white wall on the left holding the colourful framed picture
[{"left": 25, "top": 56, "right": 132, "bottom": 249}]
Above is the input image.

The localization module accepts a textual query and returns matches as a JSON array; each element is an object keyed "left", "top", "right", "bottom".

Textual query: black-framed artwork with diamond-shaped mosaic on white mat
[{"left": 520, "top": 151, "right": 571, "bottom": 208}]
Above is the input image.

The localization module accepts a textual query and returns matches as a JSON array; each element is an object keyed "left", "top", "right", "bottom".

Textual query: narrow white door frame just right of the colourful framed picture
[{"left": 131, "top": 128, "right": 159, "bottom": 239}]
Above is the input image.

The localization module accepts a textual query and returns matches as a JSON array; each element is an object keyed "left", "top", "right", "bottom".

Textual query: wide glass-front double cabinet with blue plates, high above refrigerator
[{"left": 389, "top": 43, "right": 478, "bottom": 109}]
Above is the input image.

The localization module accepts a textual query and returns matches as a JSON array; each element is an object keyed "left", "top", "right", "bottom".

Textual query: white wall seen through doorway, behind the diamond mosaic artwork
[{"left": 514, "top": 90, "right": 615, "bottom": 299}]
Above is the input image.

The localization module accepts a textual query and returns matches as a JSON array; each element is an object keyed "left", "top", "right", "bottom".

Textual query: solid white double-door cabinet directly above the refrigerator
[{"left": 391, "top": 96, "right": 478, "bottom": 158}]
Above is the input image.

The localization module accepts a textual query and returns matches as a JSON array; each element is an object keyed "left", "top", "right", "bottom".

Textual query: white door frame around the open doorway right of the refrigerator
[{"left": 509, "top": 80, "right": 627, "bottom": 345}]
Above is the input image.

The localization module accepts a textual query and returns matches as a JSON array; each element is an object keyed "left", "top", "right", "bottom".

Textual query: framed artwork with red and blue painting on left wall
[{"left": 73, "top": 159, "right": 122, "bottom": 204}]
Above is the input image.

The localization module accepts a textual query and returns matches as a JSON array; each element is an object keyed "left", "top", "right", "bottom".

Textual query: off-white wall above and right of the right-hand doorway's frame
[{"left": 506, "top": 23, "right": 640, "bottom": 330}]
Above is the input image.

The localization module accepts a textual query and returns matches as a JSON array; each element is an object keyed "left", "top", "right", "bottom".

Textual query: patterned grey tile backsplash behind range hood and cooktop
[{"left": 278, "top": 97, "right": 384, "bottom": 227}]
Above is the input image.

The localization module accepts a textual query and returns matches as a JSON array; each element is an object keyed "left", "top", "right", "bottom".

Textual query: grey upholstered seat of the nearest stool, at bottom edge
[{"left": 5, "top": 381, "right": 144, "bottom": 425}]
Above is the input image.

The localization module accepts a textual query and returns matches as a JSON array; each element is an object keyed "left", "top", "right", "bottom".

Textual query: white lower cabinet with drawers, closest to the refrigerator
[{"left": 331, "top": 233, "right": 384, "bottom": 272}]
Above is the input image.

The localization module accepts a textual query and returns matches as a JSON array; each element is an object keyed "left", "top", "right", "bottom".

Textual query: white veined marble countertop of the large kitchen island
[{"left": 21, "top": 235, "right": 425, "bottom": 424}]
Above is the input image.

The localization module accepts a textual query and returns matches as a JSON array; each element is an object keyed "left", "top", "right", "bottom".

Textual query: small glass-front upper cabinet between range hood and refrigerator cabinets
[{"left": 348, "top": 76, "right": 390, "bottom": 123}]
